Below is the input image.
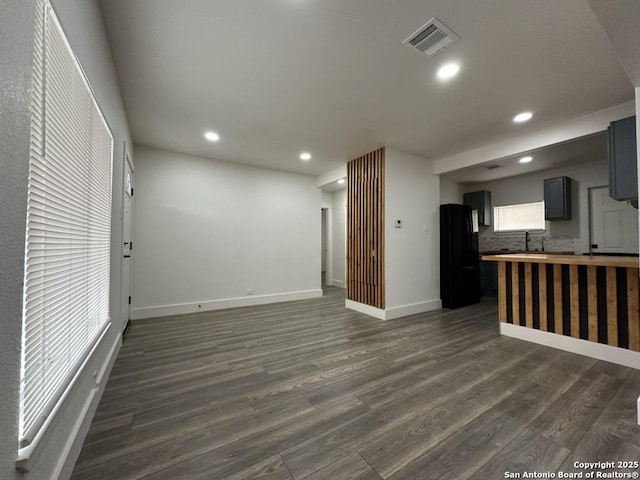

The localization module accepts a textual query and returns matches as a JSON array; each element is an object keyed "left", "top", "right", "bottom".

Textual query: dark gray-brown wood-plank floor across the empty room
[{"left": 73, "top": 288, "right": 640, "bottom": 480}]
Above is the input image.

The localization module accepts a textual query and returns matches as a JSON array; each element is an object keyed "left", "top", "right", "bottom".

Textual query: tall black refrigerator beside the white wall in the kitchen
[{"left": 440, "top": 203, "right": 480, "bottom": 308}]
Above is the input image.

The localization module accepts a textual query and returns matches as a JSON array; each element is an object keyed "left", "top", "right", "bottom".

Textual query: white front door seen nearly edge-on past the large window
[{"left": 120, "top": 155, "right": 134, "bottom": 331}]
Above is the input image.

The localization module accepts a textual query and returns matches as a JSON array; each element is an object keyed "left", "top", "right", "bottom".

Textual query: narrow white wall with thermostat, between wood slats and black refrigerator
[{"left": 385, "top": 148, "right": 440, "bottom": 318}]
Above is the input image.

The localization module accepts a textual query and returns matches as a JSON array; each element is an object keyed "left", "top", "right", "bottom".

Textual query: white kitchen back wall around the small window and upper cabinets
[{"left": 463, "top": 159, "right": 609, "bottom": 254}]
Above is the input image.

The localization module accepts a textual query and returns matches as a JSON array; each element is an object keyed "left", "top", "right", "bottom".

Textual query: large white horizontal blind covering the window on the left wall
[{"left": 20, "top": 1, "right": 113, "bottom": 447}]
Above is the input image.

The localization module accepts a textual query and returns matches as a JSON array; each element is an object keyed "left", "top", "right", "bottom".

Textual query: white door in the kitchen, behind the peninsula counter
[{"left": 589, "top": 187, "right": 638, "bottom": 253}]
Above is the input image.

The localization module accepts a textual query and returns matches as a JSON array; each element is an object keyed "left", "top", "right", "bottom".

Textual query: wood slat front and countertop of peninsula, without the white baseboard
[{"left": 483, "top": 255, "right": 640, "bottom": 352}]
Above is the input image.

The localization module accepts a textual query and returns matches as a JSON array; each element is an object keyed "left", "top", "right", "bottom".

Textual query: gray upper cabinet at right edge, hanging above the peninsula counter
[{"left": 608, "top": 117, "right": 638, "bottom": 200}]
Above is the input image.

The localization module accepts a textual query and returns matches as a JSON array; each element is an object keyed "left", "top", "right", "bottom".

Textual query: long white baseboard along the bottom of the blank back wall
[{"left": 131, "top": 289, "right": 322, "bottom": 320}]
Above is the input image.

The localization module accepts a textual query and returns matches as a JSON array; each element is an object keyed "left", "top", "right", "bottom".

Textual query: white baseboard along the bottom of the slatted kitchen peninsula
[{"left": 500, "top": 322, "right": 640, "bottom": 372}]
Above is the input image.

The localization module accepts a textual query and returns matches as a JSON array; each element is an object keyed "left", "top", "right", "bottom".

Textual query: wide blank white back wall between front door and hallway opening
[{"left": 132, "top": 146, "right": 322, "bottom": 318}]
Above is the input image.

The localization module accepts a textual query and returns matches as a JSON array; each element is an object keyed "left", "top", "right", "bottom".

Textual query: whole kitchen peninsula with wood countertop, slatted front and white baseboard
[{"left": 482, "top": 253, "right": 640, "bottom": 368}]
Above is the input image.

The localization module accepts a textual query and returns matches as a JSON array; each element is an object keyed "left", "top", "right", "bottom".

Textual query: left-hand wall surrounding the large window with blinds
[{"left": 0, "top": 0, "right": 131, "bottom": 480}]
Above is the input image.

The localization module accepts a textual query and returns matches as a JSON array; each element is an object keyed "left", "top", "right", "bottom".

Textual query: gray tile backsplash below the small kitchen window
[{"left": 478, "top": 227, "right": 578, "bottom": 252}]
